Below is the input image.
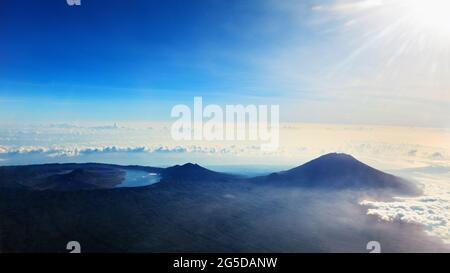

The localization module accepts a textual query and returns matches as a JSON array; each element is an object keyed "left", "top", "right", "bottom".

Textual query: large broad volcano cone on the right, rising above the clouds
[{"left": 252, "top": 153, "right": 419, "bottom": 194}]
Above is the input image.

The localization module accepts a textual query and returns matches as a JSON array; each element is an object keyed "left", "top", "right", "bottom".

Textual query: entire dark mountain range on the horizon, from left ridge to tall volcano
[{"left": 0, "top": 153, "right": 419, "bottom": 194}]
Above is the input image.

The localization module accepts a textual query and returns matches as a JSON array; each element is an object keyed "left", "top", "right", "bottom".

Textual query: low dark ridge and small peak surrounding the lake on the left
[{"left": 0, "top": 163, "right": 234, "bottom": 191}]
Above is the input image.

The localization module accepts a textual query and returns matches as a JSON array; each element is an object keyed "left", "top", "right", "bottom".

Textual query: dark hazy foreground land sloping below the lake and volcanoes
[{"left": 0, "top": 155, "right": 449, "bottom": 252}]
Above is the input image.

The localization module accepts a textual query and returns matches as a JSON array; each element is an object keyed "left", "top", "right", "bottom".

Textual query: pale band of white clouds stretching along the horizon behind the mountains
[{"left": 0, "top": 122, "right": 450, "bottom": 167}]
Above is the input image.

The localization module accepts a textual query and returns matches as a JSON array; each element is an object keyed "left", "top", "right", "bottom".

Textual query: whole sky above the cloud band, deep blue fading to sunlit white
[{"left": 0, "top": 0, "right": 450, "bottom": 127}]
